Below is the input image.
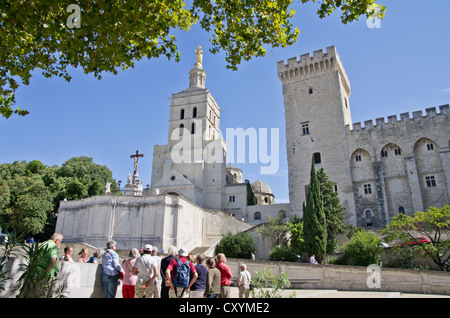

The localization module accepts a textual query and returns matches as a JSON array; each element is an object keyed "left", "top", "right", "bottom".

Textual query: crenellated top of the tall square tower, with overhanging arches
[{"left": 277, "top": 46, "right": 350, "bottom": 95}]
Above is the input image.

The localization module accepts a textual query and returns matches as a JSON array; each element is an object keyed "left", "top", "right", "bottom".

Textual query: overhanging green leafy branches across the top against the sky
[{"left": 0, "top": 0, "right": 385, "bottom": 118}]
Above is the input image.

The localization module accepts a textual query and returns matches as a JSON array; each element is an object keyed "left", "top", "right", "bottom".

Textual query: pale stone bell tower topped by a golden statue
[{"left": 152, "top": 46, "right": 226, "bottom": 209}]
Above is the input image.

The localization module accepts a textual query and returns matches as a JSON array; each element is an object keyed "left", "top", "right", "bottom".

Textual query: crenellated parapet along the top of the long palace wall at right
[{"left": 351, "top": 105, "right": 450, "bottom": 132}]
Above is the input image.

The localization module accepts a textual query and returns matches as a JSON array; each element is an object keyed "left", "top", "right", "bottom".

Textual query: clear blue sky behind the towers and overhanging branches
[{"left": 0, "top": 0, "right": 450, "bottom": 203}]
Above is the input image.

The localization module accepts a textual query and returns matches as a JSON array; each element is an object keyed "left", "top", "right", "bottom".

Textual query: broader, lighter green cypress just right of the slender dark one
[{"left": 317, "top": 168, "right": 345, "bottom": 253}]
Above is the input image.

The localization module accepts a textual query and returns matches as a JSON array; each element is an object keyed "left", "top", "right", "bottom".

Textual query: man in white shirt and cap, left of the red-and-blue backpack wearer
[{"left": 132, "top": 244, "right": 158, "bottom": 298}]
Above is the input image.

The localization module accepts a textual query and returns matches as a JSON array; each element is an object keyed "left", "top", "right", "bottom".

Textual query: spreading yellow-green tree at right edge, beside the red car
[{"left": 382, "top": 205, "right": 450, "bottom": 271}]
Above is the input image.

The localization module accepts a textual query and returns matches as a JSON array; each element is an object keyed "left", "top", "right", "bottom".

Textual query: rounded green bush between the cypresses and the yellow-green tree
[{"left": 342, "top": 228, "right": 383, "bottom": 266}]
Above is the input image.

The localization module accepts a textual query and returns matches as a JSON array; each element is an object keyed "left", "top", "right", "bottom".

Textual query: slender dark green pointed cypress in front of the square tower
[{"left": 303, "top": 159, "right": 327, "bottom": 263}]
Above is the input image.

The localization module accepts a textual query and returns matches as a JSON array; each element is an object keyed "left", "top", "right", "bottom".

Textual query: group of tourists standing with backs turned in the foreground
[{"left": 102, "top": 241, "right": 251, "bottom": 298}]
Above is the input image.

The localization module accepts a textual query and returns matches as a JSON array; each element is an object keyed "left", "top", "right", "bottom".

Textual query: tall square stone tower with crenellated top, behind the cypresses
[{"left": 278, "top": 46, "right": 356, "bottom": 224}]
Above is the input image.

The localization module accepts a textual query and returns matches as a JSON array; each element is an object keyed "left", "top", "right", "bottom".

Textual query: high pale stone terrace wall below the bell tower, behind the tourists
[{"left": 56, "top": 195, "right": 252, "bottom": 250}]
